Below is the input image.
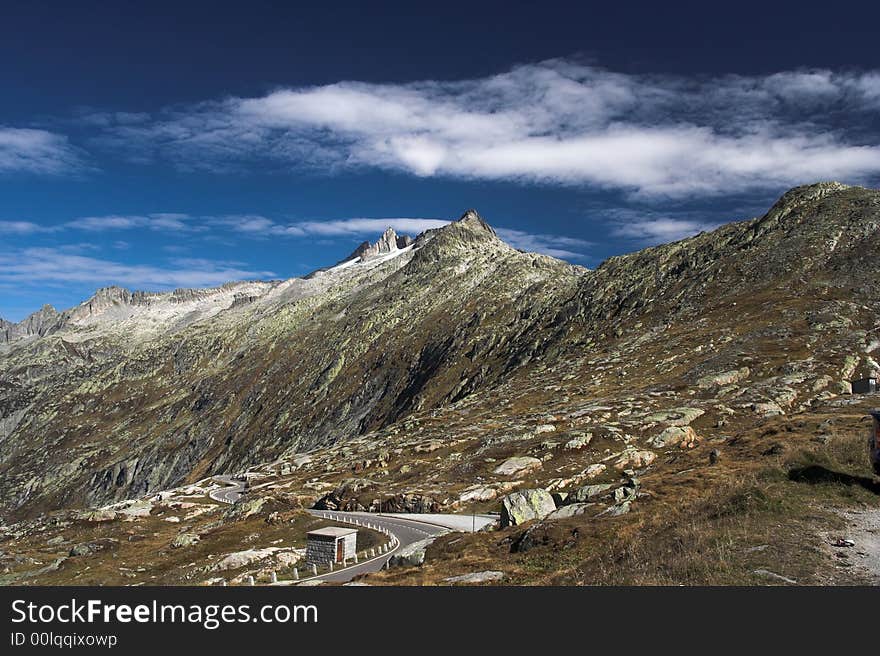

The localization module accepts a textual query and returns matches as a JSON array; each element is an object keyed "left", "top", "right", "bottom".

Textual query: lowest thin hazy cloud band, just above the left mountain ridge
[{"left": 0, "top": 248, "right": 275, "bottom": 289}]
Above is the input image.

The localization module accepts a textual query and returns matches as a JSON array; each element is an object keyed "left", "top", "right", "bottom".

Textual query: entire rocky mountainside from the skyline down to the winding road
[{"left": 0, "top": 183, "right": 880, "bottom": 532}]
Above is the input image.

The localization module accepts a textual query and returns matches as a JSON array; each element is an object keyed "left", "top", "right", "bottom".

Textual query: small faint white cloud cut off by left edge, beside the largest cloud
[{"left": 0, "top": 126, "right": 82, "bottom": 175}]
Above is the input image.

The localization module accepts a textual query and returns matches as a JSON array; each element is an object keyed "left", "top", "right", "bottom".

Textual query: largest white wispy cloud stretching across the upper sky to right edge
[{"left": 91, "top": 60, "right": 880, "bottom": 197}]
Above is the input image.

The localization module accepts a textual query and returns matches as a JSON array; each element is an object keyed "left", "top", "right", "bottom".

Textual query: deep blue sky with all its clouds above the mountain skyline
[{"left": 0, "top": 1, "right": 880, "bottom": 320}]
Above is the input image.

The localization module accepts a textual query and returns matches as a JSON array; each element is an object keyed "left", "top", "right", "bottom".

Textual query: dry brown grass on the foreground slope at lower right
[{"left": 371, "top": 407, "right": 880, "bottom": 585}]
